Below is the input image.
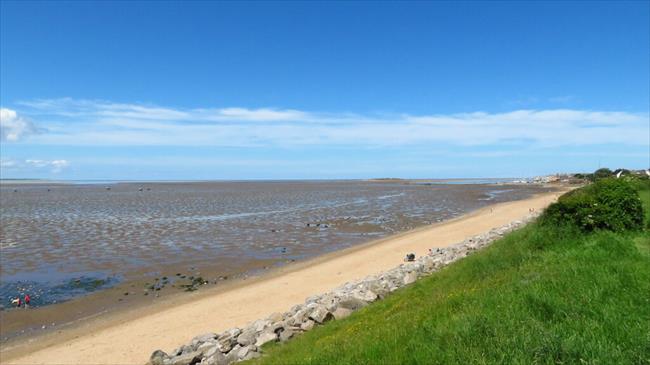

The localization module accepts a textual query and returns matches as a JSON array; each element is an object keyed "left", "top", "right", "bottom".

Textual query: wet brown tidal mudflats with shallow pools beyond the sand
[{"left": 0, "top": 181, "right": 543, "bottom": 306}]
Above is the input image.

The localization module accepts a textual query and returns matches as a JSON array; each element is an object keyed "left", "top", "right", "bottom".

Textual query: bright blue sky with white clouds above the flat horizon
[{"left": 0, "top": 1, "right": 650, "bottom": 179}]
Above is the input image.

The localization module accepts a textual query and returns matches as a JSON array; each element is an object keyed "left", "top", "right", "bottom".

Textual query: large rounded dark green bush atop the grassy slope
[{"left": 541, "top": 178, "right": 643, "bottom": 232}]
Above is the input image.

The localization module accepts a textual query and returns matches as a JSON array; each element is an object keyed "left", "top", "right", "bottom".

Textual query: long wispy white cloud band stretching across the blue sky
[{"left": 6, "top": 99, "right": 650, "bottom": 148}]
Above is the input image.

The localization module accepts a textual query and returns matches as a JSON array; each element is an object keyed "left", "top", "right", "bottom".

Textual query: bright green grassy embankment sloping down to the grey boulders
[{"left": 256, "top": 180, "right": 650, "bottom": 364}]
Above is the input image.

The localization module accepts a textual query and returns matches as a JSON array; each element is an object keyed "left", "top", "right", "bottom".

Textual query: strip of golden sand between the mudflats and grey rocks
[{"left": 0, "top": 192, "right": 560, "bottom": 364}]
